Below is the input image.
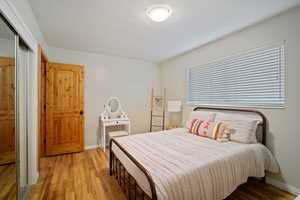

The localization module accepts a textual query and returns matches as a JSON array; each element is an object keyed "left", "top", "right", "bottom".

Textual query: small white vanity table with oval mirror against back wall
[{"left": 100, "top": 97, "right": 130, "bottom": 152}]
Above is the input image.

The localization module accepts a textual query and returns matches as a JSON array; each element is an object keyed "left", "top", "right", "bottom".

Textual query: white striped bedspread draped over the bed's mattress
[{"left": 112, "top": 129, "right": 279, "bottom": 200}]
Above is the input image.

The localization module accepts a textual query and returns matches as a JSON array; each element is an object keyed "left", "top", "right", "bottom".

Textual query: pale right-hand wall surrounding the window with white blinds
[{"left": 161, "top": 7, "right": 300, "bottom": 192}]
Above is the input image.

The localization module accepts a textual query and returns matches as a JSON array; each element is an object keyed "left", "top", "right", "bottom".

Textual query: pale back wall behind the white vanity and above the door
[{"left": 48, "top": 47, "right": 160, "bottom": 147}]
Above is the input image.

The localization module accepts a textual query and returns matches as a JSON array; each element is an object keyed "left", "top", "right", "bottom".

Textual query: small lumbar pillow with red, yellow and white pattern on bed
[{"left": 187, "top": 118, "right": 230, "bottom": 141}]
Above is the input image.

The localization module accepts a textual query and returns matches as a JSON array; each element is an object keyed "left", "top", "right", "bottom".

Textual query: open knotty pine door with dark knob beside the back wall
[{"left": 46, "top": 63, "right": 84, "bottom": 156}]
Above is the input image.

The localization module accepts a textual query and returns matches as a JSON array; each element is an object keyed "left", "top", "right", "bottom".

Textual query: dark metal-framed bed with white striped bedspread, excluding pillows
[{"left": 110, "top": 107, "right": 279, "bottom": 200}]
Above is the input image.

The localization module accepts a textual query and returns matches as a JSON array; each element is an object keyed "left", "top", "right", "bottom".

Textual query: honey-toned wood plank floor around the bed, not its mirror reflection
[{"left": 28, "top": 149, "right": 295, "bottom": 200}]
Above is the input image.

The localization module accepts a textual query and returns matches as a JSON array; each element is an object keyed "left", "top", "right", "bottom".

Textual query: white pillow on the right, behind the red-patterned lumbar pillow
[{"left": 215, "top": 113, "right": 260, "bottom": 144}]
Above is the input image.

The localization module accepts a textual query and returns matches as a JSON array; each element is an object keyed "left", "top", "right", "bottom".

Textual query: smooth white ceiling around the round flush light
[{"left": 29, "top": 0, "right": 300, "bottom": 62}]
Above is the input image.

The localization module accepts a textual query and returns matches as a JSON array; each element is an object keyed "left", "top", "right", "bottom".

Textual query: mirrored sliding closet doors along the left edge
[{"left": 0, "top": 14, "right": 29, "bottom": 200}]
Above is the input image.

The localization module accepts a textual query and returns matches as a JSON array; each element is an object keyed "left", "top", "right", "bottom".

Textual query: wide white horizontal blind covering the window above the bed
[{"left": 188, "top": 45, "right": 285, "bottom": 107}]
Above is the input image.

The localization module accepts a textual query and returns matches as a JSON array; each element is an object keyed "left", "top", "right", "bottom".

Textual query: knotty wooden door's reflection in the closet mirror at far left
[{"left": 0, "top": 57, "right": 15, "bottom": 165}]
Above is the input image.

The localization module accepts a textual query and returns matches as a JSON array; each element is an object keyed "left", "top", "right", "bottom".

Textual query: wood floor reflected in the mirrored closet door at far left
[{"left": 0, "top": 164, "right": 17, "bottom": 200}]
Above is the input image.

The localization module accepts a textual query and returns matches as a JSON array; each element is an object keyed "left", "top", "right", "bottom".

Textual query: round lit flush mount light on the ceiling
[{"left": 146, "top": 5, "right": 172, "bottom": 22}]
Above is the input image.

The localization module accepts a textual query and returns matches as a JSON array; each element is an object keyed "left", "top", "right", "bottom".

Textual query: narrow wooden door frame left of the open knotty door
[{"left": 37, "top": 45, "right": 48, "bottom": 171}]
